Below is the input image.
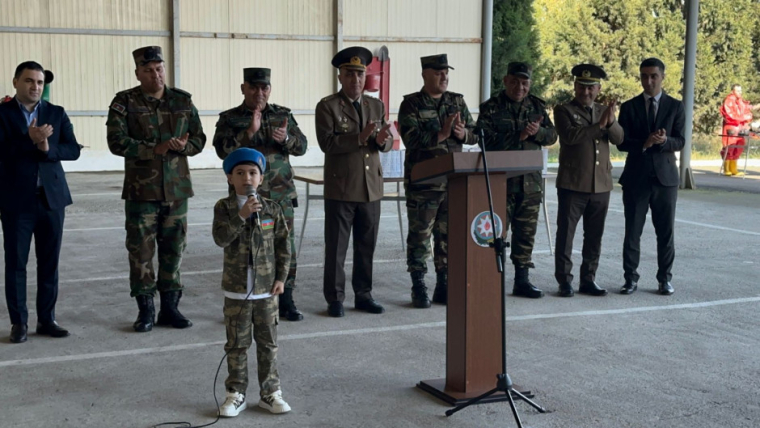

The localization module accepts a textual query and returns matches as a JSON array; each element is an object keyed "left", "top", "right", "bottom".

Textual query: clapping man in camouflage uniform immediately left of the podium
[{"left": 398, "top": 54, "right": 478, "bottom": 308}]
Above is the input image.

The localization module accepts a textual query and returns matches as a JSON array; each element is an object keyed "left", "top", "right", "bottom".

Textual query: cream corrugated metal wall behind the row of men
[{"left": 0, "top": 0, "right": 482, "bottom": 171}]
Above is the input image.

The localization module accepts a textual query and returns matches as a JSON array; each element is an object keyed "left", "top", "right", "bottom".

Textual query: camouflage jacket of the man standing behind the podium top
[{"left": 478, "top": 91, "right": 557, "bottom": 193}]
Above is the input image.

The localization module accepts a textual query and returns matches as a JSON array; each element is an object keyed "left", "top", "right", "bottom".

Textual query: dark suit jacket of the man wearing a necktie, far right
[{"left": 617, "top": 92, "right": 686, "bottom": 188}]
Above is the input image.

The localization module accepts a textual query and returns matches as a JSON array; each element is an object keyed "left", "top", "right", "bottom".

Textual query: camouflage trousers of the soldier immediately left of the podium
[{"left": 406, "top": 190, "right": 449, "bottom": 272}]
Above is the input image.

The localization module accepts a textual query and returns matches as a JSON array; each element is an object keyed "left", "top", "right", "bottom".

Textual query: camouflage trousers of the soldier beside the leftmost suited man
[{"left": 125, "top": 199, "right": 187, "bottom": 297}]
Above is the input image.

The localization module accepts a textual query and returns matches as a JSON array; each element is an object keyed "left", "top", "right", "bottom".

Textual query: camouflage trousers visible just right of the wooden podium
[{"left": 507, "top": 192, "right": 541, "bottom": 268}]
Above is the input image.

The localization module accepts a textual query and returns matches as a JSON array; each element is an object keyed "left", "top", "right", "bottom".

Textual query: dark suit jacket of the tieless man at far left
[{"left": 0, "top": 98, "right": 80, "bottom": 211}]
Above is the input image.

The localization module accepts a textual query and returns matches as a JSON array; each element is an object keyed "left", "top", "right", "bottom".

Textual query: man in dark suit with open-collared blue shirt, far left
[{"left": 0, "top": 61, "right": 80, "bottom": 343}]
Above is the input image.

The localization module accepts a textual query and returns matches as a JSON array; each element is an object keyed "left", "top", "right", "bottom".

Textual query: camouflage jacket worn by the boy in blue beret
[{"left": 211, "top": 192, "right": 290, "bottom": 294}]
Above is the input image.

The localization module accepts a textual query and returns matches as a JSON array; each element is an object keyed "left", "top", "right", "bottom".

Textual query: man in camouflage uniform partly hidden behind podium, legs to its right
[{"left": 478, "top": 62, "right": 557, "bottom": 298}]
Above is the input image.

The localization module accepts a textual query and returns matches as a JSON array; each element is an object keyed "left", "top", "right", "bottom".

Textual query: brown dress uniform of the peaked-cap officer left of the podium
[{"left": 315, "top": 92, "right": 393, "bottom": 303}]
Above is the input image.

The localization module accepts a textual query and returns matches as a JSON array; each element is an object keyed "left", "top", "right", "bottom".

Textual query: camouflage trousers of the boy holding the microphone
[{"left": 224, "top": 297, "right": 280, "bottom": 397}]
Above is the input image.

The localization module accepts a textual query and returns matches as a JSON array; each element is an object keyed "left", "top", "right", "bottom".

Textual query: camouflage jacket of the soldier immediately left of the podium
[{"left": 398, "top": 91, "right": 478, "bottom": 190}]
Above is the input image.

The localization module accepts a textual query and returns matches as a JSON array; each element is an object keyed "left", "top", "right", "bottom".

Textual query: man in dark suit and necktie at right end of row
[{"left": 618, "top": 58, "right": 685, "bottom": 295}]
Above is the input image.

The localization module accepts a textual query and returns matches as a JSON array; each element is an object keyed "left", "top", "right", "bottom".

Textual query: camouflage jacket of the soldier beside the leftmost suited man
[{"left": 106, "top": 86, "right": 206, "bottom": 201}]
